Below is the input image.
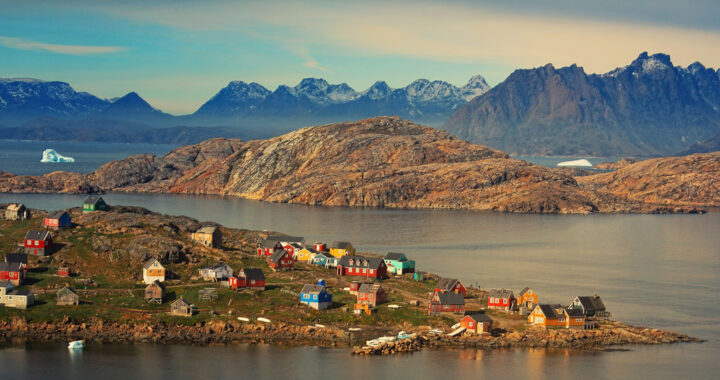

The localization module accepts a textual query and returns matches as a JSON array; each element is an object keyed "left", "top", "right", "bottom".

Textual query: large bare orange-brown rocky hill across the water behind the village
[{"left": 0, "top": 117, "right": 717, "bottom": 213}]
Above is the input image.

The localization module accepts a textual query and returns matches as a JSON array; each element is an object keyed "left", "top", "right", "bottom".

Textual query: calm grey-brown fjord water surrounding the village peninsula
[{"left": 0, "top": 194, "right": 720, "bottom": 379}]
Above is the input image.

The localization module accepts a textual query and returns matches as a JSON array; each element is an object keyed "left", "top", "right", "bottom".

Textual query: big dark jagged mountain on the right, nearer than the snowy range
[{"left": 443, "top": 53, "right": 720, "bottom": 156}]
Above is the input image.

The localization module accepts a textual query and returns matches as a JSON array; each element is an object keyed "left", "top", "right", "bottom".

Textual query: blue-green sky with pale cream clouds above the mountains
[{"left": 0, "top": 0, "right": 720, "bottom": 114}]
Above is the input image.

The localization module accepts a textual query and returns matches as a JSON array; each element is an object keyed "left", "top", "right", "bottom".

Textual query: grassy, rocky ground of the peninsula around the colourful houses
[{"left": 0, "top": 205, "right": 701, "bottom": 354}]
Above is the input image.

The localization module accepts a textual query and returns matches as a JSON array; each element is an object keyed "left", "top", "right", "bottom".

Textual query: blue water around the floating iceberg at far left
[{"left": 0, "top": 140, "right": 175, "bottom": 175}]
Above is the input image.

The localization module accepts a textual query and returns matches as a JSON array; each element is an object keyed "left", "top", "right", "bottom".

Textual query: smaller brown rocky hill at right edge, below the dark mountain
[{"left": 577, "top": 152, "right": 720, "bottom": 207}]
